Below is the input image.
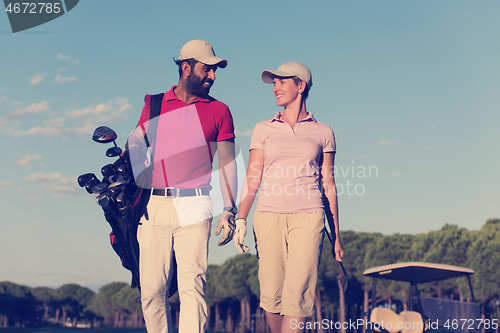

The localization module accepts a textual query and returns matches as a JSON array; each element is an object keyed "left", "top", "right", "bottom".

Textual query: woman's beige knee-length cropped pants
[{"left": 253, "top": 211, "right": 325, "bottom": 317}]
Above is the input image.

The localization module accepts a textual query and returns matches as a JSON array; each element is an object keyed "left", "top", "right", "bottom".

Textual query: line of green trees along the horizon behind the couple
[{"left": 0, "top": 219, "right": 500, "bottom": 333}]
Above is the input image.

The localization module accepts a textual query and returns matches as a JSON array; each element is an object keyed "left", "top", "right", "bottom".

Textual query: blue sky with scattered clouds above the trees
[{"left": 0, "top": 0, "right": 500, "bottom": 289}]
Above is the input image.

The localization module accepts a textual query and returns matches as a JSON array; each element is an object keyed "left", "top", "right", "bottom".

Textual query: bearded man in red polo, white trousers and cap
[{"left": 128, "top": 40, "right": 237, "bottom": 333}]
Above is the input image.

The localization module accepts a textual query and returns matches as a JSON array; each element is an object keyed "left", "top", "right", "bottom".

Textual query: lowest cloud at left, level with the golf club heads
[{"left": 23, "top": 172, "right": 81, "bottom": 197}]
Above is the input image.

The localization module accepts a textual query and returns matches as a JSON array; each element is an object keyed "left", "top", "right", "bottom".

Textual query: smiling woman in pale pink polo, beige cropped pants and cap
[{"left": 234, "top": 62, "right": 344, "bottom": 333}]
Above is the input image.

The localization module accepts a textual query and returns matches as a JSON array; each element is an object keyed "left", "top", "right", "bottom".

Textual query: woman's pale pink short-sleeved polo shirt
[{"left": 250, "top": 112, "right": 335, "bottom": 213}]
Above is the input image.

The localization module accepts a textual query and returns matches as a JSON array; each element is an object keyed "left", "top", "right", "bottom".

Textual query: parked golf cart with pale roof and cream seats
[{"left": 363, "top": 262, "right": 484, "bottom": 333}]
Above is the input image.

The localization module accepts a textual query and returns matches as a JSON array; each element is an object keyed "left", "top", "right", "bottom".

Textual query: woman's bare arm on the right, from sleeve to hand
[{"left": 321, "top": 152, "right": 344, "bottom": 261}]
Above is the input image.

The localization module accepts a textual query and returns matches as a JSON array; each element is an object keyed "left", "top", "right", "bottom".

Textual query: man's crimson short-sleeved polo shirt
[{"left": 131, "top": 86, "right": 234, "bottom": 188}]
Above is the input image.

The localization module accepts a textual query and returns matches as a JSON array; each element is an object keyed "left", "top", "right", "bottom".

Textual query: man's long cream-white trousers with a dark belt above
[{"left": 137, "top": 196, "right": 213, "bottom": 333}]
